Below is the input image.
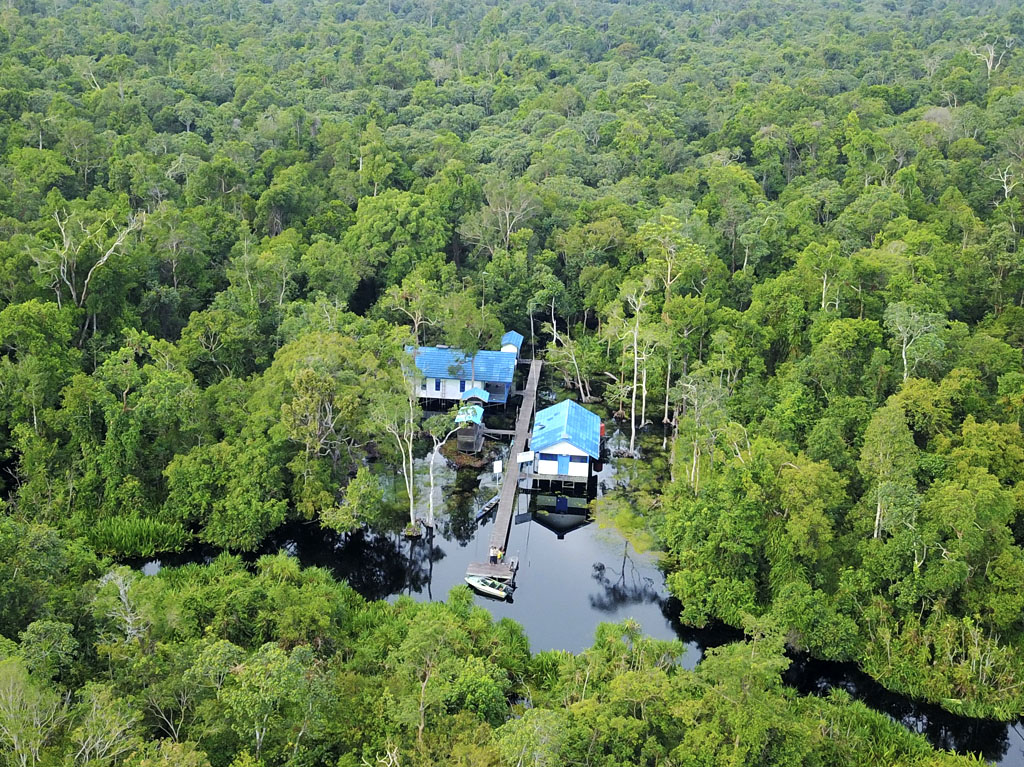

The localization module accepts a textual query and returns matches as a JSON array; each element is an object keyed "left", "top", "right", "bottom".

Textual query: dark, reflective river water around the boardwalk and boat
[{"left": 142, "top": 428, "right": 1024, "bottom": 767}]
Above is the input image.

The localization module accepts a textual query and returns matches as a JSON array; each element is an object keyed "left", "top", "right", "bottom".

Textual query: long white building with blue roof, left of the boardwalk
[{"left": 406, "top": 346, "right": 516, "bottom": 404}]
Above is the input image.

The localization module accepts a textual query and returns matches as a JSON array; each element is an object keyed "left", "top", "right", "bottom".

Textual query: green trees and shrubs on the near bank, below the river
[{"left": 0, "top": 520, "right": 983, "bottom": 767}]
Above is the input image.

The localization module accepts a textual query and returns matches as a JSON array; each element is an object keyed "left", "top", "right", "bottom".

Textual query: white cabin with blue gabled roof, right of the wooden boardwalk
[{"left": 529, "top": 399, "right": 601, "bottom": 481}]
